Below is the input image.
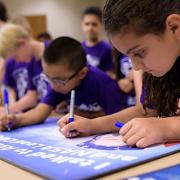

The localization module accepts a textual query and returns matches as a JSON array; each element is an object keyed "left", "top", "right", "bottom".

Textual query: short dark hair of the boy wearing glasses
[{"left": 44, "top": 37, "right": 86, "bottom": 72}]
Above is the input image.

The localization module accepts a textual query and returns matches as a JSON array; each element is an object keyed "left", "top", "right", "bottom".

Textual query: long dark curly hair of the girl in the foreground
[{"left": 103, "top": 0, "right": 180, "bottom": 116}]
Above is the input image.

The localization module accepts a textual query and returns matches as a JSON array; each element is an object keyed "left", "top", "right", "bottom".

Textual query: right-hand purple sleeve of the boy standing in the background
[{"left": 100, "top": 46, "right": 113, "bottom": 71}]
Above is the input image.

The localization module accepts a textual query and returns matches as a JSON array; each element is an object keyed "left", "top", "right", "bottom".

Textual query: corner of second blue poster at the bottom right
[{"left": 127, "top": 164, "right": 180, "bottom": 180}]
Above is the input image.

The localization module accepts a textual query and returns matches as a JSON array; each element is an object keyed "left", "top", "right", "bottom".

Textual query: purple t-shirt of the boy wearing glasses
[{"left": 41, "top": 66, "right": 125, "bottom": 114}]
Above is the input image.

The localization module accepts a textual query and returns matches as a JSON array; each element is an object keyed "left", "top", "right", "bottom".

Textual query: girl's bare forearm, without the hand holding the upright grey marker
[{"left": 91, "top": 106, "right": 146, "bottom": 134}]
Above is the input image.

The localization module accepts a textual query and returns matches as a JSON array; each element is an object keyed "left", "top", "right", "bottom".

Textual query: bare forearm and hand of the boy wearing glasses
[{"left": 0, "top": 103, "right": 53, "bottom": 131}]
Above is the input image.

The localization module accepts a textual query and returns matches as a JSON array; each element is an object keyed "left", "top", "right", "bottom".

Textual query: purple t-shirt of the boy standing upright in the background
[{"left": 82, "top": 41, "right": 113, "bottom": 71}]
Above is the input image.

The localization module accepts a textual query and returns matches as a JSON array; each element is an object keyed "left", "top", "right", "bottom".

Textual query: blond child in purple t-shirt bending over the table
[{"left": 0, "top": 24, "right": 48, "bottom": 112}]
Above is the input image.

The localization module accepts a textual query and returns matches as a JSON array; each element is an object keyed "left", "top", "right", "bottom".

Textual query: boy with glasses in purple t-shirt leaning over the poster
[{"left": 1, "top": 37, "right": 123, "bottom": 130}]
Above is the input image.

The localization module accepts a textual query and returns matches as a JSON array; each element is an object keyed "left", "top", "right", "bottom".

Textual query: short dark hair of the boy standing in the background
[{"left": 82, "top": 6, "right": 102, "bottom": 23}]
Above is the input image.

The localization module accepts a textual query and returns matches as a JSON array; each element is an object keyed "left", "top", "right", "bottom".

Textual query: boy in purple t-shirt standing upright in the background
[{"left": 82, "top": 7, "right": 113, "bottom": 75}]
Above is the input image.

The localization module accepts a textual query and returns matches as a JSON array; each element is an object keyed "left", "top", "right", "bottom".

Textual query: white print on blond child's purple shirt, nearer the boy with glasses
[{"left": 33, "top": 73, "right": 48, "bottom": 100}]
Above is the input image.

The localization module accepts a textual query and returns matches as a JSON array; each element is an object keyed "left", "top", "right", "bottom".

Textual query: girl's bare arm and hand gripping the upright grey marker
[{"left": 58, "top": 106, "right": 155, "bottom": 137}]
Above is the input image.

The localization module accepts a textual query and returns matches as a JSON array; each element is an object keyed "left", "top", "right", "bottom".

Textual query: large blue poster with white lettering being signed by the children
[{"left": 0, "top": 118, "right": 180, "bottom": 180}]
